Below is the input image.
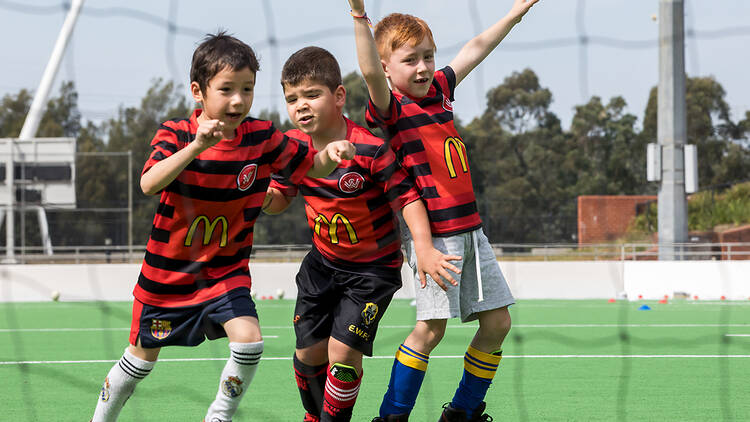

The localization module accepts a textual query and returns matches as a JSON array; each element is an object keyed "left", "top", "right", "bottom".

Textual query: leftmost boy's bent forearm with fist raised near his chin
[{"left": 141, "top": 120, "right": 224, "bottom": 195}]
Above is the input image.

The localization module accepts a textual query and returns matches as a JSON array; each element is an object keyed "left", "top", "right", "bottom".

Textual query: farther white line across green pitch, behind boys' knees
[{"left": 0, "top": 324, "right": 750, "bottom": 332}]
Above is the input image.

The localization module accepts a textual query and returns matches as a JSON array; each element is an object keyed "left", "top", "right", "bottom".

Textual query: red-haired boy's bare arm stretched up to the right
[{"left": 450, "top": 0, "right": 539, "bottom": 85}]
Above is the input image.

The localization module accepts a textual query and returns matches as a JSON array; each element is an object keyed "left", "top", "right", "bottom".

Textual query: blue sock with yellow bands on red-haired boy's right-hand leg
[{"left": 451, "top": 346, "right": 503, "bottom": 419}]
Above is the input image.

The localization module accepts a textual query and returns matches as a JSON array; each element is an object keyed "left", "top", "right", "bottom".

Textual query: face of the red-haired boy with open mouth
[{"left": 383, "top": 37, "right": 435, "bottom": 98}]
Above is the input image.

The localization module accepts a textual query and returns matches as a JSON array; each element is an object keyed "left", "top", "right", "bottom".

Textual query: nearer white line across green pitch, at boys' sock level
[{"left": 0, "top": 355, "right": 750, "bottom": 365}]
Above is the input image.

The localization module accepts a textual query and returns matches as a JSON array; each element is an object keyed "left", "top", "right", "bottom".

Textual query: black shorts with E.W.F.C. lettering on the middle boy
[{"left": 294, "top": 249, "right": 401, "bottom": 356}]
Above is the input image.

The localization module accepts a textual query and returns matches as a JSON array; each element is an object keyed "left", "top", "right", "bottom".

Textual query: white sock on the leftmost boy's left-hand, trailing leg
[{"left": 92, "top": 349, "right": 156, "bottom": 422}]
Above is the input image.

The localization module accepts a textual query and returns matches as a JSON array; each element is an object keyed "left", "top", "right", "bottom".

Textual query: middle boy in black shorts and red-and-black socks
[{"left": 266, "top": 47, "right": 459, "bottom": 421}]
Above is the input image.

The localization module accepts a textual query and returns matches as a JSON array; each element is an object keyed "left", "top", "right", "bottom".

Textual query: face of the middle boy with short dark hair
[{"left": 284, "top": 79, "right": 346, "bottom": 140}]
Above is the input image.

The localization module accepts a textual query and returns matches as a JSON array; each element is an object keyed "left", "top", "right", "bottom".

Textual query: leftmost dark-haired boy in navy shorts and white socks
[{"left": 93, "top": 32, "right": 354, "bottom": 422}]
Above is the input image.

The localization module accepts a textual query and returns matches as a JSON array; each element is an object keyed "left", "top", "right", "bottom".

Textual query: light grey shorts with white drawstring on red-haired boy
[{"left": 401, "top": 224, "right": 515, "bottom": 322}]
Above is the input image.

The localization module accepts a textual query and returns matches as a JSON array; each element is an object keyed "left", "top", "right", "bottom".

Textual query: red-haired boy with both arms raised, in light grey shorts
[{"left": 349, "top": 0, "right": 539, "bottom": 422}]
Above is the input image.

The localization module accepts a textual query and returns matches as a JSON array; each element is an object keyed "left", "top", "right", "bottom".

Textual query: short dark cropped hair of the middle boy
[{"left": 281, "top": 47, "right": 344, "bottom": 92}]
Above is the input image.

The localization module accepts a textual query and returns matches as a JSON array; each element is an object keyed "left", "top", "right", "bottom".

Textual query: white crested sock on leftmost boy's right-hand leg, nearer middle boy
[{"left": 206, "top": 341, "right": 263, "bottom": 422}]
